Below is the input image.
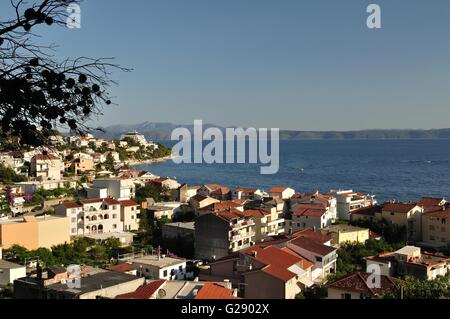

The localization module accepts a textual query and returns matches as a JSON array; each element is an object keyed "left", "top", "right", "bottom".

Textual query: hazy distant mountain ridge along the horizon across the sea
[{"left": 94, "top": 122, "right": 450, "bottom": 141}]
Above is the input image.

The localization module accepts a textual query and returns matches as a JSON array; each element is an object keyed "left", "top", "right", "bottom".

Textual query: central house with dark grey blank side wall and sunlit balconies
[{"left": 195, "top": 209, "right": 256, "bottom": 260}]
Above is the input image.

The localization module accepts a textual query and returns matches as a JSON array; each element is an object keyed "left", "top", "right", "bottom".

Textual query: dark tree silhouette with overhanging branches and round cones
[{"left": 0, "top": 0, "right": 128, "bottom": 146}]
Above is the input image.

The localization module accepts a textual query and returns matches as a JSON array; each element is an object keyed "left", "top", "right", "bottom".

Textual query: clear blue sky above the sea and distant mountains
[{"left": 0, "top": 0, "right": 450, "bottom": 130}]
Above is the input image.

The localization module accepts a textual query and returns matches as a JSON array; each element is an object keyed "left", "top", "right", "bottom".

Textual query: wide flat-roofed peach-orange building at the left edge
[{"left": 0, "top": 215, "right": 70, "bottom": 250}]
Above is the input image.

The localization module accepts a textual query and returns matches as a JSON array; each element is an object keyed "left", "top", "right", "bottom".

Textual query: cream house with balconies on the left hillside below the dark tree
[{"left": 30, "top": 153, "right": 64, "bottom": 181}]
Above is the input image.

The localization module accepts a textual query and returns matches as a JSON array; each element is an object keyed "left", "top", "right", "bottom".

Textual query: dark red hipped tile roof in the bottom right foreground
[{"left": 326, "top": 272, "right": 398, "bottom": 296}]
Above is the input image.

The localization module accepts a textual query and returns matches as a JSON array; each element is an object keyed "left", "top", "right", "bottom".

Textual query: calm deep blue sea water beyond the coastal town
[{"left": 138, "top": 140, "right": 450, "bottom": 201}]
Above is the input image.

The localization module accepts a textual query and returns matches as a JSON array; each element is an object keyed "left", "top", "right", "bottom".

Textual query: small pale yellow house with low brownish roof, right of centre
[{"left": 321, "top": 224, "right": 370, "bottom": 247}]
